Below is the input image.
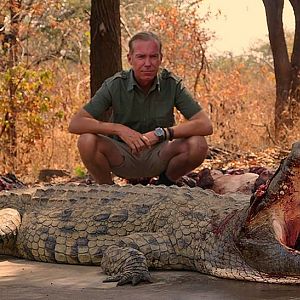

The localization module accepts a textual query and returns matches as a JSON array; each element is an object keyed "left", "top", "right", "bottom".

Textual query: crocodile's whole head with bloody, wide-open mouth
[{"left": 238, "top": 142, "right": 300, "bottom": 276}]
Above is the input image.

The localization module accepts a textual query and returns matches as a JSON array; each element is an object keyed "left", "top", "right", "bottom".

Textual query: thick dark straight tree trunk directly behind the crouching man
[{"left": 90, "top": 0, "right": 122, "bottom": 96}]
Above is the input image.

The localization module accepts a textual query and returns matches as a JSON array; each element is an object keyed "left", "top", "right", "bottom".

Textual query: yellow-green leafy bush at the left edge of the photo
[{"left": 0, "top": 64, "right": 57, "bottom": 144}]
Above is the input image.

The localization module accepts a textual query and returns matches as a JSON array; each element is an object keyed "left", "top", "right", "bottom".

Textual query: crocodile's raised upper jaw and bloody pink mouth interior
[{"left": 248, "top": 142, "right": 300, "bottom": 250}]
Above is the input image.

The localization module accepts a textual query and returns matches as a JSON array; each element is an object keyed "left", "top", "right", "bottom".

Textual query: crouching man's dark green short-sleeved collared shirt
[{"left": 84, "top": 69, "right": 202, "bottom": 133}]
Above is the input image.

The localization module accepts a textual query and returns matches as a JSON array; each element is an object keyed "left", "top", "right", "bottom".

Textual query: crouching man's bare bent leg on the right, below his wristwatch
[{"left": 160, "top": 136, "right": 208, "bottom": 182}]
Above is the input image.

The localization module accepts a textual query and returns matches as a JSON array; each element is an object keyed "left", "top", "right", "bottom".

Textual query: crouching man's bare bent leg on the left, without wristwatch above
[{"left": 77, "top": 133, "right": 124, "bottom": 184}]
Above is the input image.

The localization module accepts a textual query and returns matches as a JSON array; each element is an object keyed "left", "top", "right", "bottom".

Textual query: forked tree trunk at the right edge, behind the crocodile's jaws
[{"left": 263, "top": 0, "right": 300, "bottom": 142}]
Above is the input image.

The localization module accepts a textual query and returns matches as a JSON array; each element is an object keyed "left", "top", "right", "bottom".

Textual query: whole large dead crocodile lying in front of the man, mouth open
[{"left": 0, "top": 142, "right": 300, "bottom": 285}]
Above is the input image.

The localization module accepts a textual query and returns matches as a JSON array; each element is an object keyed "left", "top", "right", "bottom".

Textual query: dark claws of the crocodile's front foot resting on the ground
[{"left": 103, "top": 271, "right": 152, "bottom": 286}]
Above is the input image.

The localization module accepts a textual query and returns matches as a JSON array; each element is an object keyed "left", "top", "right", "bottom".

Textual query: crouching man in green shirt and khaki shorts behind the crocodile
[{"left": 69, "top": 32, "right": 213, "bottom": 185}]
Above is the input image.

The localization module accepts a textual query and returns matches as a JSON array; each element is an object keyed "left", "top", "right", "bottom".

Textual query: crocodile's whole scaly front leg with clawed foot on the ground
[{"left": 101, "top": 233, "right": 175, "bottom": 285}]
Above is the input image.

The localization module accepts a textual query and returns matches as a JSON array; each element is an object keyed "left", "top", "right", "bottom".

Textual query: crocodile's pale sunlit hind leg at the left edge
[{"left": 0, "top": 208, "right": 21, "bottom": 255}]
